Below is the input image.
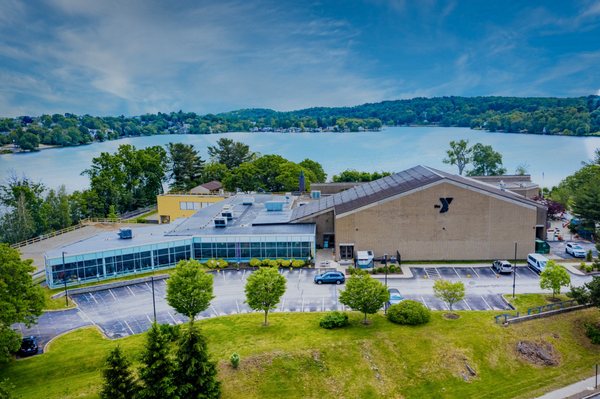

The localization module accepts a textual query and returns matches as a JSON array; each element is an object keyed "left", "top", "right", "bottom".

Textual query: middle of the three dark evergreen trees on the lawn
[{"left": 140, "top": 323, "right": 177, "bottom": 399}]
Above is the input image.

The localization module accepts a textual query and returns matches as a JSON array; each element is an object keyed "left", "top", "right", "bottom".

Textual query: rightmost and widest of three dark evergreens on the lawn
[{"left": 175, "top": 323, "right": 221, "bottom": 399}]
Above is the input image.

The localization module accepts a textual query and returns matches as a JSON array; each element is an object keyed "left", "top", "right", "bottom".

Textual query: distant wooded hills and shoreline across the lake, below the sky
[{"left": 0, "top": 96, "right": 600, "bottom": 150}]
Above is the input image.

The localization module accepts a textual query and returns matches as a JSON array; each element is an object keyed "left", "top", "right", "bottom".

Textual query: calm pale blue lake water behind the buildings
[{"left": 0, "top": 127, "right": 600, "bottom": 191}]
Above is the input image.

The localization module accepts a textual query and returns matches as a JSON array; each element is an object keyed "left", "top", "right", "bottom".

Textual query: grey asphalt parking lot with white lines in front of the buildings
[{"left": 14, "top": 267, "right": 520, "bottom": 345}]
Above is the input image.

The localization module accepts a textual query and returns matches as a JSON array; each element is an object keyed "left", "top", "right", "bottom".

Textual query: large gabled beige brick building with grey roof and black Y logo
[{"left": 290, "top": 166, "right": 546, "bottom": 260}]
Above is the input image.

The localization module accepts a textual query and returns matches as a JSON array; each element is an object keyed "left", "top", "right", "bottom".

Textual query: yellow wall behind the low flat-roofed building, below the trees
[{"left": 156, "top": 194, "right": 225, "bottom": 223}]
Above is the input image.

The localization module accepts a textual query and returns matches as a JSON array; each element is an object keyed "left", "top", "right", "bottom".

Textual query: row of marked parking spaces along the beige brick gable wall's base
[{"left": 410, "top": 266, "right": 539, "bottom": 281}]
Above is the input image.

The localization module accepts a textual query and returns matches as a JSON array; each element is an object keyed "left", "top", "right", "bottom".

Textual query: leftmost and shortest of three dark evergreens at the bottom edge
[{"left": 100, "top": 346, "right": 138, "bottom": 399}]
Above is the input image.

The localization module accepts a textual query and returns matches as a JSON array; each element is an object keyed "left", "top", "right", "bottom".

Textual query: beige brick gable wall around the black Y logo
[{"left": 335, "top": 183, "right": 537, "bottom": 260}]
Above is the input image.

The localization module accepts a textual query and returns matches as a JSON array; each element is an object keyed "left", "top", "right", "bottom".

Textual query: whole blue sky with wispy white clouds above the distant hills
[{"left": 0, "top": 0, "right": 600, "bottom": 116}]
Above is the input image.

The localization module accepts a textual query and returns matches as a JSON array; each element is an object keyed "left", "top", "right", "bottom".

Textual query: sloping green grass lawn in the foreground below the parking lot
[{"left": 0, "top": 309, "right": 600, "bottom": 399}]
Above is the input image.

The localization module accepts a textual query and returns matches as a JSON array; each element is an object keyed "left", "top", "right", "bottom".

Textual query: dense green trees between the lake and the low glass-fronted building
[{"left": 0, "top": 138, "right": 327, "bottom": 244}]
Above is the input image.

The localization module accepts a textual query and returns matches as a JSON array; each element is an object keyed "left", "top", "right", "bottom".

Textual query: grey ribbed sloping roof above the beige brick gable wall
[{"left": 291, "top": 165, "right": 543, "bottom": 221}]
